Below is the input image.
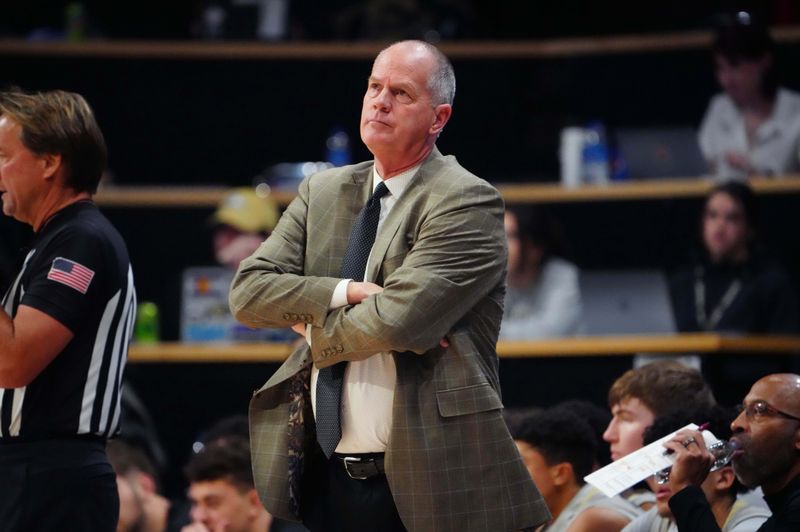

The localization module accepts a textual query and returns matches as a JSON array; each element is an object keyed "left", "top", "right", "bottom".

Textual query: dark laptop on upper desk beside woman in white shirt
[{"left": 616, "top": 127, "right": 708, "bottom": 179}]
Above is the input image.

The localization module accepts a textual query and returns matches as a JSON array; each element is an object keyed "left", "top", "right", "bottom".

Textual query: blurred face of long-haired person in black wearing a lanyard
[{"left": 703, "top": 192, "right": 749, "bottom": 262}]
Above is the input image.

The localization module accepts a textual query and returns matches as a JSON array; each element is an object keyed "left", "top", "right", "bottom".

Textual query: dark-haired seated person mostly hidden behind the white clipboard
[{"left": 623, "top": 406, "right": 770, "bottom": 532}]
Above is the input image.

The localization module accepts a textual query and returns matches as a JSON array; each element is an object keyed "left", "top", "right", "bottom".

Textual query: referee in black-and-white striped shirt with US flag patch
[{"left": 0, "top": 91, "right": 136, "bottom": 532}]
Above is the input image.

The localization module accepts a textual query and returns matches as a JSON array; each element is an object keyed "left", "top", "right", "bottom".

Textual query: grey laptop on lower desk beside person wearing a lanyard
[{"left": 579, "top": 270, "right": 675, "bottom": 336}]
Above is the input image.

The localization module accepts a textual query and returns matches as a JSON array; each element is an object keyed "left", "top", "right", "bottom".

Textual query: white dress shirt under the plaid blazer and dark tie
[{"left": 306, "top": 166, "right": 419, "bottom": 454}]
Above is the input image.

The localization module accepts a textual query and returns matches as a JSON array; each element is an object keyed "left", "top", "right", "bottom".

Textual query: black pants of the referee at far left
[{"left": 0, "top": 438, "right": 119, "bottom": 532}]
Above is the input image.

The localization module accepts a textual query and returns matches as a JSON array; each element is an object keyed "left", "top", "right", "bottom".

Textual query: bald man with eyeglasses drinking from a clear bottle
[{"left": 664, "top": 374, "right": 800, "bottom": 532}]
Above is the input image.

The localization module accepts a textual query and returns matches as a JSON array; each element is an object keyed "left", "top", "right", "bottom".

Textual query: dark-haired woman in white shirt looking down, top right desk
[{"left": 699, "top": 12, "right": 800, "bottom": 179}]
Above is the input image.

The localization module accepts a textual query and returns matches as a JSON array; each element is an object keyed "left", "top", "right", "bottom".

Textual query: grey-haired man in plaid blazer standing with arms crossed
[{"left": 230, "top": 41, "right": 549, "bottom": 532}]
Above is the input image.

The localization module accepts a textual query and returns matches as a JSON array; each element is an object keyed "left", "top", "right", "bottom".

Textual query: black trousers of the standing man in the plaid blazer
[{"left": 301, "top": 446, "right": 406, "bottom": 532}]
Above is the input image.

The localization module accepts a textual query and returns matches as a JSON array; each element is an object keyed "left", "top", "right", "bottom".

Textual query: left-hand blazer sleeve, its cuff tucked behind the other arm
[{"left": 229, "top": 176, "right": 339, "bottom": 328}]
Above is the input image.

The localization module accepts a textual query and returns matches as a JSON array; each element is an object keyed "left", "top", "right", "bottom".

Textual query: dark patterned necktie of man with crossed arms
[{"left": 316, "top": 182, "right": 389, "bottom": 458}]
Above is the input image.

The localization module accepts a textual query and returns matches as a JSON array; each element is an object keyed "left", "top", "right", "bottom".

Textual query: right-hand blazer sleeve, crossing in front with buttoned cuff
[{"left": 310, "top": 178, "right": 506, "bottom": 368}]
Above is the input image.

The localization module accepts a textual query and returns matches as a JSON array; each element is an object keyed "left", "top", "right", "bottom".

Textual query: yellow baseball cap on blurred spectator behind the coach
[{"left": 211, "top": 187, "right": 280, "bottom": 233}]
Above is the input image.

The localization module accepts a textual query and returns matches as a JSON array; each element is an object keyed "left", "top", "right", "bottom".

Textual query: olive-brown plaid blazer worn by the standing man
[{"left": 230, "top": 149, "right": 549, "bottom": 532}]
